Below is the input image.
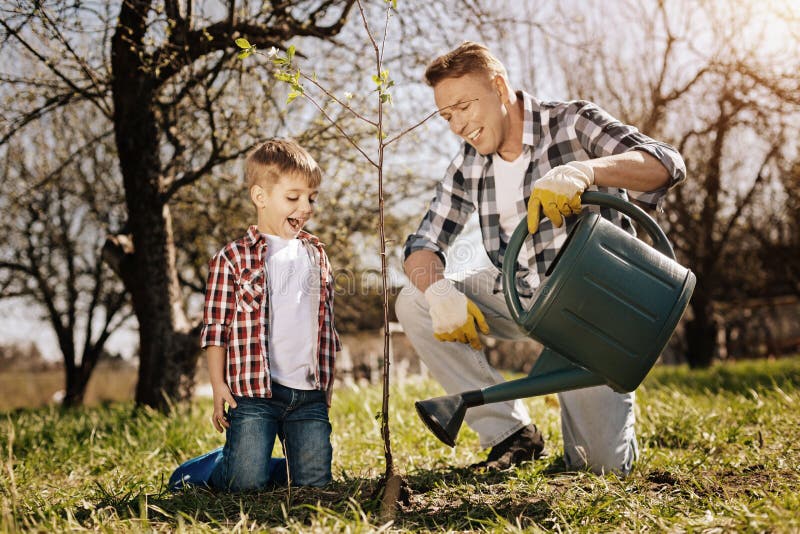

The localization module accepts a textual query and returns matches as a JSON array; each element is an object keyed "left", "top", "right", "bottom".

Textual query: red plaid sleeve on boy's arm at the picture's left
[{"left": 200, "top": 253, "right": 236, "bottom": 348}]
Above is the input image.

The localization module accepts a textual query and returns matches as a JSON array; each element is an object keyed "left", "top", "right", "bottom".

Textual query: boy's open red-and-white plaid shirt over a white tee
[{"left": 200, "top": 226, "right": 341, "bottom": 397}]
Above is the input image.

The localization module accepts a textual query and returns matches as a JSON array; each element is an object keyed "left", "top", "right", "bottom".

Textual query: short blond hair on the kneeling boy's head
[{"left": 244, "top": 139, "right": 322, "bottom": 191}]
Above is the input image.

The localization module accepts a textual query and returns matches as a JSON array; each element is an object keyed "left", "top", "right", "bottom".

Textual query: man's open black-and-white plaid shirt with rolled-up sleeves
[{"left": 404, "top": 92, "right": 686, "bottom": 297}]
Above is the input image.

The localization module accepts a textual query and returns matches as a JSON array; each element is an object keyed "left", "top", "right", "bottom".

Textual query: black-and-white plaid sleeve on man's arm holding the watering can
[{"left": 575, "top": 102, "right": 686, "bottom": 208}]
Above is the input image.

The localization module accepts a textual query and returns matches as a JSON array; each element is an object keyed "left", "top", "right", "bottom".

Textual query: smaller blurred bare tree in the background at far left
[{"left": 0, "top": 110, "right": 130, "bottom": 406}]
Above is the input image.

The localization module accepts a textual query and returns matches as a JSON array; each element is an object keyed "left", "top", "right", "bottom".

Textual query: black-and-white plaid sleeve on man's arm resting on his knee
[{"left": 403, "top": 151, "right": 475, "bottom": 264}]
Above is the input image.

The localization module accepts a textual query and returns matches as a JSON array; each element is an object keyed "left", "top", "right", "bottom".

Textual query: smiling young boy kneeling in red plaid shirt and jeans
[{"left": 170, "top": 139, "right": 340, "bottom": 491}]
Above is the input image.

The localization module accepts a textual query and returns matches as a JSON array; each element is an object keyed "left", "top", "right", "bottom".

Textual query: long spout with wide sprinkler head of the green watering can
[{"left": 415, "top": 348, "right": 606, "bottom": 447}]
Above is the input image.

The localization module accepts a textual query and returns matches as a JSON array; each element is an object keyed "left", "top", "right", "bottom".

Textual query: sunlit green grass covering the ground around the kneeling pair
[{"left": 0, "top": 357, "right": 800, "bottom": 532}]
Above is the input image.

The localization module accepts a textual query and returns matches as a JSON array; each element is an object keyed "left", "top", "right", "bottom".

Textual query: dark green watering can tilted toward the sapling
[{"left": 415, "top": 191, "right": 695, "bottom": 447}]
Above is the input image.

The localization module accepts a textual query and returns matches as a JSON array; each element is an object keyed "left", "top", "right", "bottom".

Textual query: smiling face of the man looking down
[{"left": 433, "top": 73, "right": 510, "bottom": 156}]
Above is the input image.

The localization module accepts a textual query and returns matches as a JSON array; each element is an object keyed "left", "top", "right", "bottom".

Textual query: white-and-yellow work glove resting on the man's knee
[{"left": 425, "top": 278, "right": 489, "bottom": 350}]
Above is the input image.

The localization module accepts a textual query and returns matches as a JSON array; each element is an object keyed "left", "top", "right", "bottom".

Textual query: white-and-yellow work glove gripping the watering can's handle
[{"left": 528, "top": 161, "right": 594, "bottom": 234}]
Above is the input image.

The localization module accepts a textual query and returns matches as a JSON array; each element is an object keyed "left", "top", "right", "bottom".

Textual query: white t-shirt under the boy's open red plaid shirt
[{"left": 266, "top": 235, "right": 316, "bottom": 389}]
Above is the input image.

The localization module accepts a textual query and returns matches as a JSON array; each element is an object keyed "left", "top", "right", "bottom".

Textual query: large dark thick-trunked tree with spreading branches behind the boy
[{"left": 0, "top": 0, "right": 352, "bottom": 408}]
